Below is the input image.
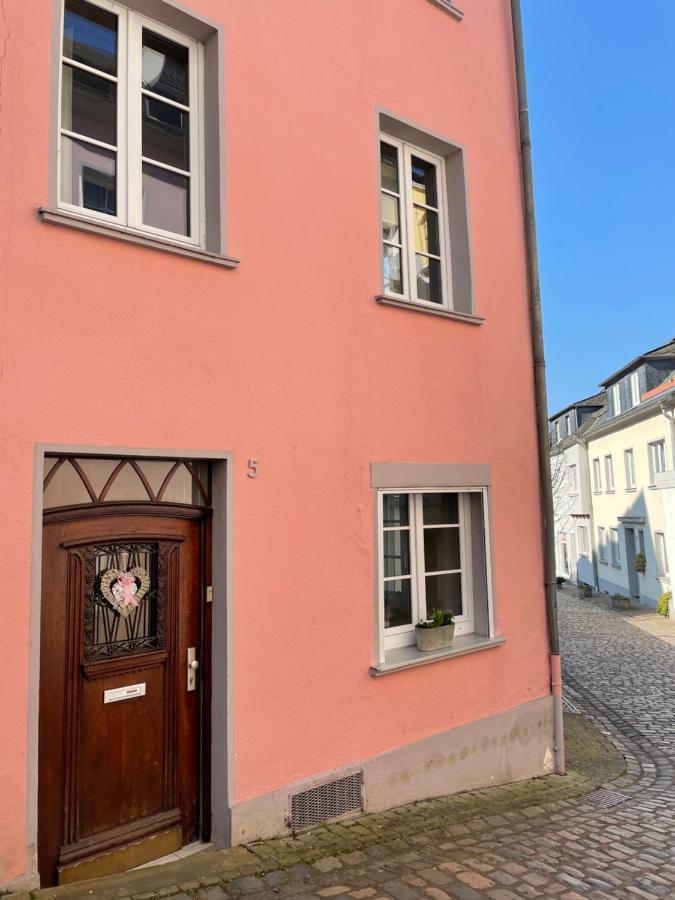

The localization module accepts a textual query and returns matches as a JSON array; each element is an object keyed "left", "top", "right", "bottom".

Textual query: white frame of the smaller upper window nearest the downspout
[{"left": 378, "top": 132, "right": 453, "bottom": 310}]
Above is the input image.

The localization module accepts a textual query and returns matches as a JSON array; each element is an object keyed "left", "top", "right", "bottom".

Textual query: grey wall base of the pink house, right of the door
[{"left": 232, "top": 696, "right": 554, "bottom": 844}]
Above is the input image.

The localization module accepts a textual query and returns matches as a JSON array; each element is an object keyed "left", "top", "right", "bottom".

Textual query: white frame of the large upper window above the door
[{"left": 56, "top": 0, "right": 206, "bottom": 248}]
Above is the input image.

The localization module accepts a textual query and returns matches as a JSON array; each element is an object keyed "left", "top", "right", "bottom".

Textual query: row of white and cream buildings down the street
[{"left": 551, "top": 340, "right": 675, "bottom": 606}]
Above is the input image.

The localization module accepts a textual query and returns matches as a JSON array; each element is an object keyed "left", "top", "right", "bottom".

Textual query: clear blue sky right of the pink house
[{"left": 521, "top": 0, "right": 675, "bottom": 413}]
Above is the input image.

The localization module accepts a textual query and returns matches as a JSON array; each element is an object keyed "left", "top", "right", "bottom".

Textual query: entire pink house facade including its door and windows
[{"left": 0, "top": 0, "right": 554, "bottom": 886}]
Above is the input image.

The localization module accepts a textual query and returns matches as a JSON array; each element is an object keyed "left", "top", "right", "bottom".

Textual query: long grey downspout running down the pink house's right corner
[{"left": 511, "top": 0, "right": 565, "bottom": 775}]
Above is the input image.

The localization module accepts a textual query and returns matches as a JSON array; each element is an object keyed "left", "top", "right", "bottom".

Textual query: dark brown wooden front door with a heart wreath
[{"left": 38, "top": 508, "right": 208, "bottom": 885}]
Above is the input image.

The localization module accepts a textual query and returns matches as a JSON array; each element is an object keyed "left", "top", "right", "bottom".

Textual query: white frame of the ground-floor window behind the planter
[{"left": 377, "top": 487, "right": 494, "bottom": 662}]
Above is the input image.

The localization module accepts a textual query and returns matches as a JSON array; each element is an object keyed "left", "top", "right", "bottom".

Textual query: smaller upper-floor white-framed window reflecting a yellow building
[{"left": 380, "top": 134, "right": 453, "bottom": 309}]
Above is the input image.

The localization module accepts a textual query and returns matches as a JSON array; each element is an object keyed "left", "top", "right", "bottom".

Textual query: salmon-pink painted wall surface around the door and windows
[{"left": 0, "top": 0, "right": 549, "bottom": 881}]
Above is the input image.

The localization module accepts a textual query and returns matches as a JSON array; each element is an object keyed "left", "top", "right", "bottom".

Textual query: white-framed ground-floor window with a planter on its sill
[{"left": 378, "top": 488, "right": 490, "bottom": 650}]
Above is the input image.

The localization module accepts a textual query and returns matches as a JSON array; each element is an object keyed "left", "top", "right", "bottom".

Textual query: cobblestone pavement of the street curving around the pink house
[{"left": 26, "top": 594, "right": 675, "bottom": 900}]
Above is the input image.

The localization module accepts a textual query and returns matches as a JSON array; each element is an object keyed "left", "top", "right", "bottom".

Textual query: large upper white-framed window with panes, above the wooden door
[{"left": 57, "top": 0, "right": 204, "bottom": 246}]
